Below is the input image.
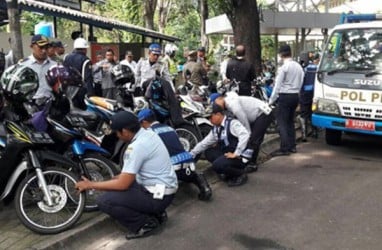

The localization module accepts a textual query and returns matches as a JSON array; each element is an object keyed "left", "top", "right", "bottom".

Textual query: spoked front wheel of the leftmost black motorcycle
[{"left": 15, "top": 167, "right": 86, "bottom": 234}]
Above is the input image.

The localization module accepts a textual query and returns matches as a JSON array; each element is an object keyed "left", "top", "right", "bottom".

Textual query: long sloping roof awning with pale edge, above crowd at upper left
[{"left": 19, "top": 0, "right": 180, "bottom": 42}]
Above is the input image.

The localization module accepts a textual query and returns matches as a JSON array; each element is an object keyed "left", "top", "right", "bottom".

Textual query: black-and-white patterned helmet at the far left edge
[{"left": 0, "top": 64, "right": 39, "bottom": 103}]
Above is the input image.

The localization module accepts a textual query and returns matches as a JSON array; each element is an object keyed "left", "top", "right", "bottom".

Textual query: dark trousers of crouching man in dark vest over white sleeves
[{"left": 204, "top": 147, "right": 245, "bottom": 178}]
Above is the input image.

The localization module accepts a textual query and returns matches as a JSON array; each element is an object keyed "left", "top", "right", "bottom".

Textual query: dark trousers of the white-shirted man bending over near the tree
[{"left": 248, "top": 113, "right": 273, "bottom": 164}]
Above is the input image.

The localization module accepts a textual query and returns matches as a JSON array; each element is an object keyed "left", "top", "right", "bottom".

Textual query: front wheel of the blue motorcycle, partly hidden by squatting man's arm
[{"left": 82, "top": 153, "right": 120, "bottom": 212}]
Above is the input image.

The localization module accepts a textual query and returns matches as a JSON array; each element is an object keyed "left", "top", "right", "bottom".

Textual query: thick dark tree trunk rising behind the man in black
[{"left": 227, "top": 0, "right": 262, "bottom": 74}]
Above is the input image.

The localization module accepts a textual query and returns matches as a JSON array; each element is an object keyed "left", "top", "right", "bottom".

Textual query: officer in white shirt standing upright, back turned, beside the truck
[{"left": 269, "top": 45, "right": 304, "bottom": 156}]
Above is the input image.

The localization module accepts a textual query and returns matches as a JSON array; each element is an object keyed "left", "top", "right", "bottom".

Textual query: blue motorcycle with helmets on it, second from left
[{"left": 1, "top": 65, "right": 119, "bottom": 210}]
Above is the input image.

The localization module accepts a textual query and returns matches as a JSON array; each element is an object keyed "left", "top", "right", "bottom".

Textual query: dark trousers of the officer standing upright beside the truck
[{"left": 276, "top": 94, "right": 299, "bottom": 152}]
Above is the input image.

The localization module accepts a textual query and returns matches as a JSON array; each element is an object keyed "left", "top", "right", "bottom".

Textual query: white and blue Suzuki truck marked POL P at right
[{"left": 312, "top": 14, "right": 382, "bottom": 145}]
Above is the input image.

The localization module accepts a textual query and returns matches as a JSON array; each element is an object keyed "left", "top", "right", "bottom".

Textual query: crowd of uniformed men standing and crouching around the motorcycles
[{"left": 1, "top": 35, "right": 319, "bottom": 239}]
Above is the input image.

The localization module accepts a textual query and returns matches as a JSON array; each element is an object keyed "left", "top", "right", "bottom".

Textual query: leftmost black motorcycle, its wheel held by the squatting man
[{"left": 0, "top": 121, "right": 86, "bottom": 234}]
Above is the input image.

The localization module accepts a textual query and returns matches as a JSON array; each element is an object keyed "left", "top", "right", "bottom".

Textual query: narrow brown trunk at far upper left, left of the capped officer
[{"left": 7, "top": 0, "right": 24, "bottom": 62}]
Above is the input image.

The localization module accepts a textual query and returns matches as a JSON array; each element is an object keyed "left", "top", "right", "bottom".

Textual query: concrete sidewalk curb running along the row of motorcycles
[{"left": 29, "top": 134, "right": 279, "bottom": 250}]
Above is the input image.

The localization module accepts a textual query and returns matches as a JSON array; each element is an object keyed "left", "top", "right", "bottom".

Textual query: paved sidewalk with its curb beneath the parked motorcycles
[{"left": 0, "top": 134, "right": 279, "bottom": 250}]
